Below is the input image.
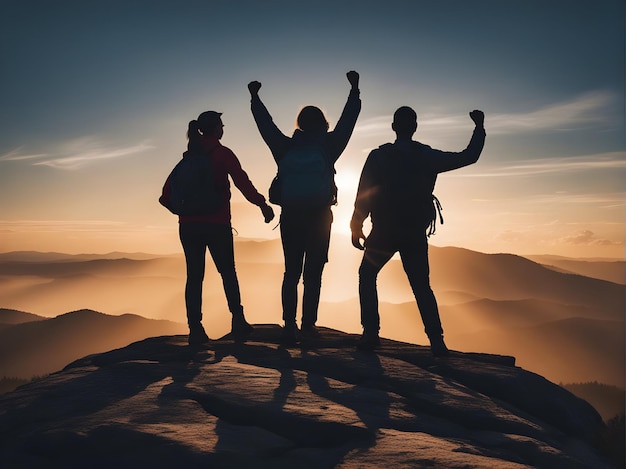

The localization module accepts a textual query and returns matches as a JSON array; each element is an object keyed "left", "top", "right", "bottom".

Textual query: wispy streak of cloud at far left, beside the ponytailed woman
[{"left": 0, "top": 137, "right": 154, "bottom": 170}]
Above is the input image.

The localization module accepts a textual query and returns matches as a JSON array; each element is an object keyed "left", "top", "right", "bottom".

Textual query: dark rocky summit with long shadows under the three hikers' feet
[{"left": 0, "top": 325, "right": 605, "bottom": 469}]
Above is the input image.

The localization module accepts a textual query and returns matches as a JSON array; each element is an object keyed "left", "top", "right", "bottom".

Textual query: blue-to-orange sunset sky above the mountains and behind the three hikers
[{"left": 0, "top": 0, "right": 626, "bottom": 257}]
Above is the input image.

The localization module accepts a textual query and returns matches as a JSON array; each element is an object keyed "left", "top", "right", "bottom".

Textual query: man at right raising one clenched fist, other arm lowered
[{"left": 350, "top": 107, "right": 485, "bottom": 356}]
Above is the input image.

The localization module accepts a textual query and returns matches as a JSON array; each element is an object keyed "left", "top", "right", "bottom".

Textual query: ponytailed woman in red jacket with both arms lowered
[{"left": 161, "top": 111, "right": 274, "bottom": 344}]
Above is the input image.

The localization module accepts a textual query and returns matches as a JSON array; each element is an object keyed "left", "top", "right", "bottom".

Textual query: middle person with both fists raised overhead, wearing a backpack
[{"left": 248, "top": 71, "right": 361, "bottom": 342}]
